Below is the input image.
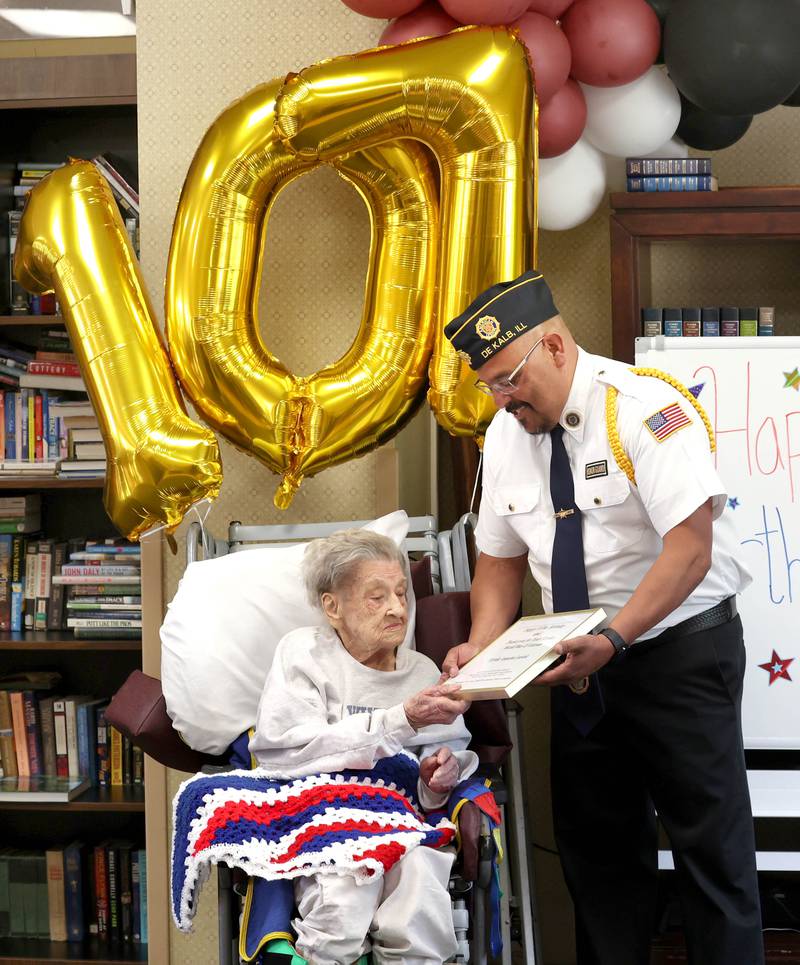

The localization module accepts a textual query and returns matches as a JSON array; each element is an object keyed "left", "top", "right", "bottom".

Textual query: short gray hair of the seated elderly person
[{"left": 302, "top": 529, "right": 408, "bottom": 606}]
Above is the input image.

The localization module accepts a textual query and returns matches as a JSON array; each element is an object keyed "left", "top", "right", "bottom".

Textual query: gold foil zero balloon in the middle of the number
[{"left": 166, "top": 80, "right": 436, "bottom": 508}]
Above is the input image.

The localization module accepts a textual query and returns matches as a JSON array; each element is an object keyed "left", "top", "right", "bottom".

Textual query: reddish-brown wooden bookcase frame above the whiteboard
[{"left": 611, "top": 186, "right": 800, "bottom": 362}]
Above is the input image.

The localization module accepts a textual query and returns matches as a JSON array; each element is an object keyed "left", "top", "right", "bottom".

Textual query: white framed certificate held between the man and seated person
[{"left": 450, "top": 607, "right": 606, "bottom": 700}]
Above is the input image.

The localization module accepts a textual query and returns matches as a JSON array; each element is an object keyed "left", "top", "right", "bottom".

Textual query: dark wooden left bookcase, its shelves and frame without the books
[{"left": 0, "top": 54, "right": 150, "bottom": 963}]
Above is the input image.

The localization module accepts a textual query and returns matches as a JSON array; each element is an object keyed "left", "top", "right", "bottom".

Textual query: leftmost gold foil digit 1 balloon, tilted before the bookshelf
[{"left": 14, "top": 161, "right": 222, "bottom": 539}]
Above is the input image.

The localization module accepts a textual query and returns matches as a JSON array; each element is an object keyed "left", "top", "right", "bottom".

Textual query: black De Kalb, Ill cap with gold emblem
[{"left": 444, "top": 268, "right": 558, "bottom": 369}]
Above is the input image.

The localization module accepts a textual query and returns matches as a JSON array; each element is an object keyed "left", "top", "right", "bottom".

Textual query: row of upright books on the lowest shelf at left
[{"left": 0, "top": 839, "right": 147, "bottom": 944}]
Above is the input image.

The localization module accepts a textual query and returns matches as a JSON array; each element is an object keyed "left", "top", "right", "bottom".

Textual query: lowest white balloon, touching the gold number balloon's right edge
[{"left": 537, "top": 137, "right": 606, "bottom": 231}]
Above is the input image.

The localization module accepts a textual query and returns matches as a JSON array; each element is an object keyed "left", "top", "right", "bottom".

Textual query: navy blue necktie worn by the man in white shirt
[{"left": 550, "top": 425, "right": 605, "bottom": 737}]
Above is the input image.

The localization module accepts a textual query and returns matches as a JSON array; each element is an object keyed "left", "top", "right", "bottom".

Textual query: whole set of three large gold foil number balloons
[{"left": 16, "top": 28, "right": 536, "bottom": 534}]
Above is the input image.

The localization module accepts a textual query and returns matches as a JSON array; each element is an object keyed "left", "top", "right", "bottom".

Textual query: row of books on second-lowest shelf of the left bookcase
[{"left": 0, "top": 684, "right": 144, "bottom": 788}]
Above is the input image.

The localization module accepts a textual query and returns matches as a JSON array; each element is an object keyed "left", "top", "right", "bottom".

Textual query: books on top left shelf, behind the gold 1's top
[{"left": 2, "top": 155, "right": 139, "bottom": 315}]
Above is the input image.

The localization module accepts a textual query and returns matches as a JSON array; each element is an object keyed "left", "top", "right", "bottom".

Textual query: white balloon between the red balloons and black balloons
[{"left": 581, "top": 67, "right": 681, "bottom": 157}]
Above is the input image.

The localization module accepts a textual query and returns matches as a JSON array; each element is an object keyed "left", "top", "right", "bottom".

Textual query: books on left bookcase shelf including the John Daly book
[{"left": 0, "top": 536, "right": 142, "bottom": 639}]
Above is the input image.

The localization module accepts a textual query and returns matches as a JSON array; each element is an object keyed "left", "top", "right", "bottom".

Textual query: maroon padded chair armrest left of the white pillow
[{"left": 106, "top": 670, "right": 227, "bottom": 773}]
